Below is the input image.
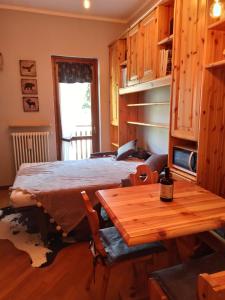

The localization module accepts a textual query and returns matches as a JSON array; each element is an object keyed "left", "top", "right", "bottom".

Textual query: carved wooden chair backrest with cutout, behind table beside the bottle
[{"left": 130, "top": 164, "right": 159, "bottom": 185}]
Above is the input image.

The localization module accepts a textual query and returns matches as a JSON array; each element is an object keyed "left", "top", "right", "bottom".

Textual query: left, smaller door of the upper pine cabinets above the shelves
[{"left": 127, "top": 25, "right": 139, "bottom": 85}]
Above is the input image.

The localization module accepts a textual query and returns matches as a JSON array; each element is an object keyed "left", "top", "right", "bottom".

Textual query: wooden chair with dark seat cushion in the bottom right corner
[{"left": 149, "top": 253, "right": 225, "bottom": 300}]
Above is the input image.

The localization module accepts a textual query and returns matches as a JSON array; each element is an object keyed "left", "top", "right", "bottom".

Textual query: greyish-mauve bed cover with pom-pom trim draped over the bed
[{"left": 11, "top": 157, "right": 143, "bottom": 233}]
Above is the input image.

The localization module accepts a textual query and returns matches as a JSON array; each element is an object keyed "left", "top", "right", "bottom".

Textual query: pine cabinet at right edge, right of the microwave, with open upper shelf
[{"left": 198, "top": 1, "right": 225, "bottom": 197}]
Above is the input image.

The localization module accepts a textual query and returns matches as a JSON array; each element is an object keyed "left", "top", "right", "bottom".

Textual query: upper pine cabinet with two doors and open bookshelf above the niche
[{"left": 127, "top": 0, "right": 174, "bottom": 90}]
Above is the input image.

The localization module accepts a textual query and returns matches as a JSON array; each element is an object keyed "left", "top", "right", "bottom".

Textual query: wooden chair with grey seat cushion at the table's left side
[{"left": 81, "top": 191, "right": 166, "bottom": 300}]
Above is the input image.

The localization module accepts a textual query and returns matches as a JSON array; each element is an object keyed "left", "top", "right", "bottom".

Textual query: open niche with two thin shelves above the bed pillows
[{"left": 120, "top": 86, "right": 170, "bottom": 153}]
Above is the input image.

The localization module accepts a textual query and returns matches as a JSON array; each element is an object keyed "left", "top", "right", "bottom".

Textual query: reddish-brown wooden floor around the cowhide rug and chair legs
[{"left": 0, "top": 191, "right": 160, "bottom": 300}]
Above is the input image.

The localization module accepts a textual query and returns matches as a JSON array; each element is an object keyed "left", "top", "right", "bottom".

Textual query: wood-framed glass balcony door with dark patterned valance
[{"left": 52, "top": 56, "right": 99, "bottom": 160}]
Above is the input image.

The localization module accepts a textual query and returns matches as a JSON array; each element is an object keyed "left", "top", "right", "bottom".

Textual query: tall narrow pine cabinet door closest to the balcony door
[{"left": 109, "top": 40, "right": 126, "bottom": 126}]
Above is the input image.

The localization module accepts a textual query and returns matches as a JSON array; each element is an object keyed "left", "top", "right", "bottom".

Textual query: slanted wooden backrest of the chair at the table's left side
[{"left": 81, "top": 191, "right": 107, "bottom": 257}]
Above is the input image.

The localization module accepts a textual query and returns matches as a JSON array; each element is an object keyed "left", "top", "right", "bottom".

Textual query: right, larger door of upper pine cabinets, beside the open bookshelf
[{"left": 138, "top": 10, "right": 158, "bottom": 82}]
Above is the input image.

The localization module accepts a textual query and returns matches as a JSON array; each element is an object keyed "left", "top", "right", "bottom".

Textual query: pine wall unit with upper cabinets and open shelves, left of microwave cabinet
[{"left": 110, "top": 0, "right": 174, "bottom": 153}]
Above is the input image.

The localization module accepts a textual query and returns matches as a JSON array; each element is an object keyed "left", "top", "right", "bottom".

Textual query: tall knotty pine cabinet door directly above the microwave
[{"left": 171, "top": 0, "right": 206, "bottom": 141}]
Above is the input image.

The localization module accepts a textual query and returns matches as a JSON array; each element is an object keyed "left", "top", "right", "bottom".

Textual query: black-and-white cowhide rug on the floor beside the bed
[{"left": 0, "top": 209, "right": 75, "bottom": 267}]
